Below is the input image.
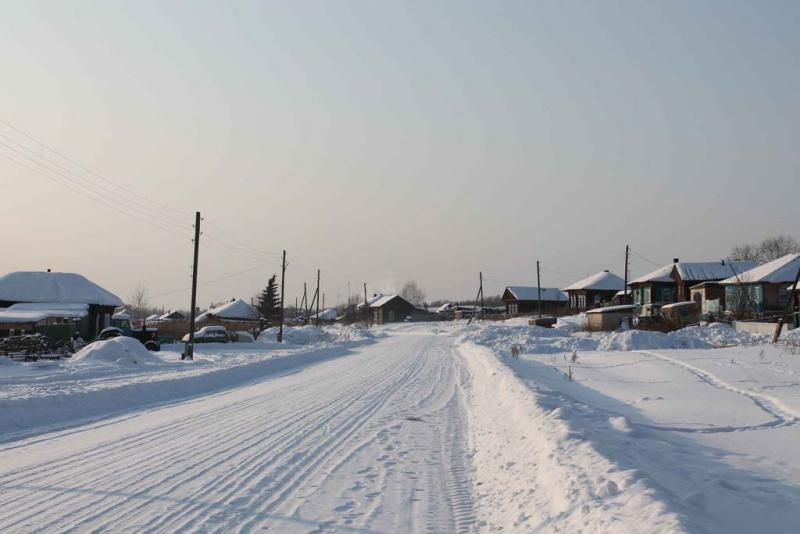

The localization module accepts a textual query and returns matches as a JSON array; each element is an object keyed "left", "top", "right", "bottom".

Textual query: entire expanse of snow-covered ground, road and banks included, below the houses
[{"left": 0, "top": 318, "right": 800, "bottom": 533}]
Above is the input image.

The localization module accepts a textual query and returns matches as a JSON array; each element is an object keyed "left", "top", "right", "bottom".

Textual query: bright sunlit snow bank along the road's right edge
[{"left": 461, "top": 344, "right": 683, "bottom": 532}]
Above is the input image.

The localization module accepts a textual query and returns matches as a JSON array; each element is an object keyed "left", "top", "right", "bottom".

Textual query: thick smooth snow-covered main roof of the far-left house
[{"left": 0, "top": 271, "right": 122, "bottom": 306}]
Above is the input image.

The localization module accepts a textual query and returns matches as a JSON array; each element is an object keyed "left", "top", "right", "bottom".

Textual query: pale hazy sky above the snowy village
[{"left": 0, "top": 0, "right": 800, "bottom": 309}]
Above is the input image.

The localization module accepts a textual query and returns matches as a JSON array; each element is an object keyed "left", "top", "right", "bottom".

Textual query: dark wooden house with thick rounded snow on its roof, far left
[{"left": 0, "top": 271, "right": 122, "bottom": 340}]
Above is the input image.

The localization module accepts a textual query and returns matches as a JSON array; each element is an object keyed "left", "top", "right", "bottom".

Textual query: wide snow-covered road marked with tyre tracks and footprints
[{"left": 0, "top": 330, "right": 475, "bottom": 532}]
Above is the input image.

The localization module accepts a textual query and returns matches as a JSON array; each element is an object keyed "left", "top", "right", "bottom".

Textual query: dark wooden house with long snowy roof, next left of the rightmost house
[{"left": 629, "top": 258, "right": 756, "bottom": 306}]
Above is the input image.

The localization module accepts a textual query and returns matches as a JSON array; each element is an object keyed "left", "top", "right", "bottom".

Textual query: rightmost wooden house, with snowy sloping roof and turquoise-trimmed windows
[{"left": 720, "top": 254, "right": 800, "bottom": 316}]
